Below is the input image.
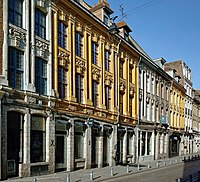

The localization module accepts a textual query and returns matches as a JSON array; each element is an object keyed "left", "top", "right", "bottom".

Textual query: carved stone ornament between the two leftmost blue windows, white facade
[{"left": 8, "top": 25, "right": 26, "bottom": 49}]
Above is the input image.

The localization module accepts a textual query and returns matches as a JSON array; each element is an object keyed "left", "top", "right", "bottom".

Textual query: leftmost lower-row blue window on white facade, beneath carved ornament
[{"left": 8, "top": 47, "right": 24, "bottom": 89}]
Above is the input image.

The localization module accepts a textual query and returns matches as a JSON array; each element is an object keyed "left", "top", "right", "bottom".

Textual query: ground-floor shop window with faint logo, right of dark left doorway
[{"left": 30, "top": 115, "right": 46, "bottom": 162}]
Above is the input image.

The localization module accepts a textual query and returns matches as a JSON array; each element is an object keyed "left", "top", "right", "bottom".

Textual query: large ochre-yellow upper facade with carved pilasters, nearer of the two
[{"left": 52, "top": 0, "right": 139, "bottom": 126}]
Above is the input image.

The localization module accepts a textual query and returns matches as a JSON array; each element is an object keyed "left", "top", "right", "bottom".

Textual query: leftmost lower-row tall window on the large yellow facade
[{"left": 58, "top": 66, "right": 67, "bottom": 99}]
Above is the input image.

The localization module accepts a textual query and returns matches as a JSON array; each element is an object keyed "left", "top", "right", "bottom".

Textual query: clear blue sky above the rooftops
[{"left": 85, "top": 0, "right": 200, "bottom": 90}]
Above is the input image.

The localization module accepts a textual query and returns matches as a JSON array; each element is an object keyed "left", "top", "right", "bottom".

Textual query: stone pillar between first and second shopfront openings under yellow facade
[{"left": 67, "top": 120, "right": 74, "bottom": 171}]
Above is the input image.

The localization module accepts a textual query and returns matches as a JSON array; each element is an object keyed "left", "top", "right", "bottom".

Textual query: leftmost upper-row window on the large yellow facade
[{"left": 58, "top": 21, "right": 67, "bottom": 49}]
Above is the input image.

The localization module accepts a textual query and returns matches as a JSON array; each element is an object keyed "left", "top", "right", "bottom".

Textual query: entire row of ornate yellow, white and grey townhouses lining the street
[{"left": 0, "top": 0, "right": 200, "bottom": 180}]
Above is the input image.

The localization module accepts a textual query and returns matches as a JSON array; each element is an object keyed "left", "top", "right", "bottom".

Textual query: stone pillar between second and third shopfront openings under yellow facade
[{"left": 84, "top": 127, "right": 91, "bottom": 169}]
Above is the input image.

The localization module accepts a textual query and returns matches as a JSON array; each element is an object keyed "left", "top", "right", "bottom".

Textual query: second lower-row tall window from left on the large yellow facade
[{"left": 76, "top": 73, "right": 83, "bottom": 103}]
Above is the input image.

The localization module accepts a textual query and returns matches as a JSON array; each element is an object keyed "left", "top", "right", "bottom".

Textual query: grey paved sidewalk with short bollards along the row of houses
[{"left": 5, "top": 154, "right": 199, "bottom": 182}]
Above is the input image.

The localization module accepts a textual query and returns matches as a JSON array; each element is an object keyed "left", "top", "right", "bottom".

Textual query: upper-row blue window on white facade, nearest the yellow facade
[{"left": 35, "top": 8, "right": 46, "bottom": 39}]
